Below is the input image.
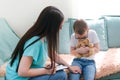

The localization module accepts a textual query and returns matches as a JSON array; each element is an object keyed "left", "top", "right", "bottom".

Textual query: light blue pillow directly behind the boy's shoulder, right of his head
[{"left": 86, "top": 19, "right": 108, "bottom": 51}]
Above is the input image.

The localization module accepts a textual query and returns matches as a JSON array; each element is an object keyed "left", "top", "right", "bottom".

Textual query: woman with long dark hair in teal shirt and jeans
[{"left": 6, "top": 6, "right": 80, "bottom": 80}]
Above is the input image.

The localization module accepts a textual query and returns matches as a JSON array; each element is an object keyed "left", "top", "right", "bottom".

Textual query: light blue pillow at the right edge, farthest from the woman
[{"left": 104, "top": 16, "right": 120, "bottom": 48}]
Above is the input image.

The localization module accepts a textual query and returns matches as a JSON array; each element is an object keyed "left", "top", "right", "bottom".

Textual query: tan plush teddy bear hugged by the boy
[{"left": 76, "top": 38, "right": 94, "bottom": 58}]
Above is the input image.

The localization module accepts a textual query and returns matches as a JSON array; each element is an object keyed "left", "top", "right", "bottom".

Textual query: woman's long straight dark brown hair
[{"left": 10, "top": 6, "right": 64, "bottom": 72}]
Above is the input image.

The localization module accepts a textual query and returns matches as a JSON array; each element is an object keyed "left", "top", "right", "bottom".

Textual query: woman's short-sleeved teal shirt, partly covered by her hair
[{"left": 6, "top": 36, "right": 48, "bottom": 80}]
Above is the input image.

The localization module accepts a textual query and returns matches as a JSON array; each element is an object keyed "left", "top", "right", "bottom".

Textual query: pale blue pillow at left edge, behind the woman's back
[{"left": 0, "top": 18, "right": 19, "bottom": 62}]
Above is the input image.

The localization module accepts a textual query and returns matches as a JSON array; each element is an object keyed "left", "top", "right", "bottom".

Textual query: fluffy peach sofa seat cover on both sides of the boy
[{"left": 60, "top": 48, "right": 120, "bottom": 79}]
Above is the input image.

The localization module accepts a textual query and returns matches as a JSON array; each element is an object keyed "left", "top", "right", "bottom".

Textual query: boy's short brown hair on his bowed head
[{"left": 73, "top": 19, "right": 88, "bottom": 35}]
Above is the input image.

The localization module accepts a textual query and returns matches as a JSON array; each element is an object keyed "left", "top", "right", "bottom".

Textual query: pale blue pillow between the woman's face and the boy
[{"left": 59, "top": 21, "right": 70, "bottom": 54}]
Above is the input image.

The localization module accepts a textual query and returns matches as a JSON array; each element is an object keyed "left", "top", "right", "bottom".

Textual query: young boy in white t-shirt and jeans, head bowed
[{"left": 70, "top": 19, "right": 99, "bottom": 80}]
